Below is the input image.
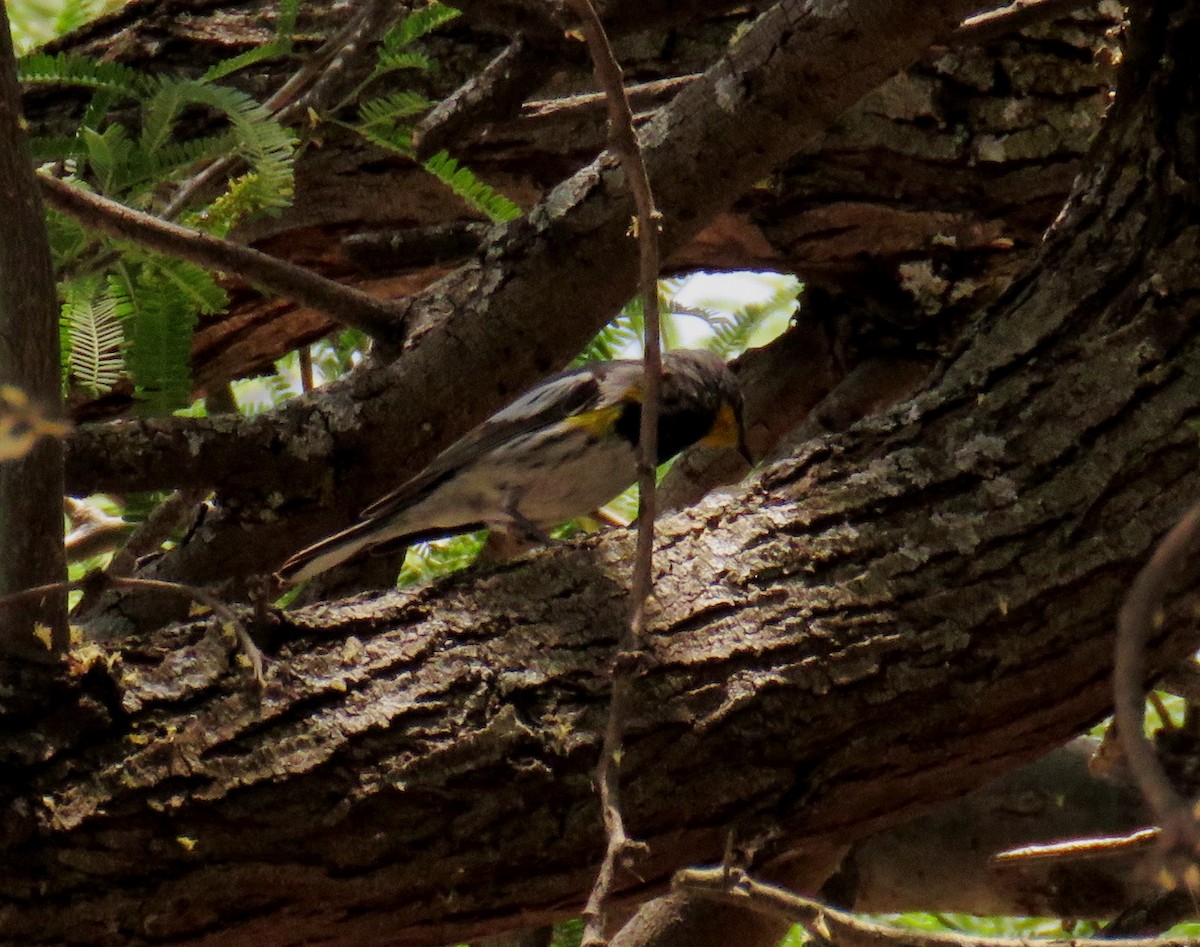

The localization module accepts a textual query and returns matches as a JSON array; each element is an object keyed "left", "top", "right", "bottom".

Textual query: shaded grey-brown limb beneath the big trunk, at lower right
[{"left": 823, "top": 738, "right": 1160, "bottom": 918}]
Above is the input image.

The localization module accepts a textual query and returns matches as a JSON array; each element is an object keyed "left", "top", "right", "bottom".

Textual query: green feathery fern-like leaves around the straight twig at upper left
[{"left": 19, "top": 38, "right": 299, "bottom": 413}]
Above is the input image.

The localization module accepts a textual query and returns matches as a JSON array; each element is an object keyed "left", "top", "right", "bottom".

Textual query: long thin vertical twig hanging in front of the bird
[{"left": 568, "top": 0, "right": 662, "bottom": 947}]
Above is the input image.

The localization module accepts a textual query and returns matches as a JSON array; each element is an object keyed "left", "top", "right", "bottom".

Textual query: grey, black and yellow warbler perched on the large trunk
[{"left": 277, "top": 349, "right": 750, "bottom": 583}]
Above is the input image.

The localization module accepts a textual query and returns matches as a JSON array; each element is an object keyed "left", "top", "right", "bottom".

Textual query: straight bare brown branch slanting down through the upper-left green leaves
[{"left": 37, "top": 174, "right": 406, "bottom": 340}]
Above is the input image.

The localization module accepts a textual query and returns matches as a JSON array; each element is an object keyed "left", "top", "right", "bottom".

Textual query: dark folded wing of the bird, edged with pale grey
[{"left": 360, "top": 362, "right": 617, "bottom": 520}]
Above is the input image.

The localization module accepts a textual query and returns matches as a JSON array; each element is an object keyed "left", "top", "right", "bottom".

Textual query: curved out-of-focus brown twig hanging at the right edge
[{"left": 1112, "top": 503, "right": 1200, "bottom": 851}]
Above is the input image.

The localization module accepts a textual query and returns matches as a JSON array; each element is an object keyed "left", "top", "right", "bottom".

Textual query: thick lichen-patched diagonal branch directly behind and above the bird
[{"left": 60, "top": 1, "right": 988, "bottom": 627}]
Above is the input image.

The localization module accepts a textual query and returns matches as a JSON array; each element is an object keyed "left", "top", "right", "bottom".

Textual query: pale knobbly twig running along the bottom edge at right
[{"left": 671, "top": 867, "right": 1195, "bottom": 947}]
